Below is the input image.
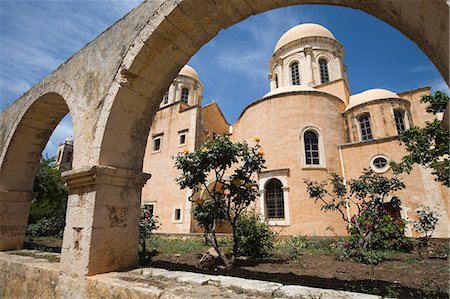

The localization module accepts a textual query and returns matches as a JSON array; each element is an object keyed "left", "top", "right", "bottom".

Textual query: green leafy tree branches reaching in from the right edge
[{"left": 390, "top": 91, "right": 450, "bottom": 187}]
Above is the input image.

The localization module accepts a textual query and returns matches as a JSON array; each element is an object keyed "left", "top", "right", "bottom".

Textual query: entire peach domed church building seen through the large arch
[{"left": 142, "top": 24, "right": 449, "bottom": 237}]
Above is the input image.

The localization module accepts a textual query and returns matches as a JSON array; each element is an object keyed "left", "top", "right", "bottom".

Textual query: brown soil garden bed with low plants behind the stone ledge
[{"left": 26, "top": 236, "right": 450, "bottom": 298}]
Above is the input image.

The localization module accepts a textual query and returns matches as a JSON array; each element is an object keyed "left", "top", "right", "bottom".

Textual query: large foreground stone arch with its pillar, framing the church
[{"left": 0, "top": 0, "right": 442, "bottom": 277}]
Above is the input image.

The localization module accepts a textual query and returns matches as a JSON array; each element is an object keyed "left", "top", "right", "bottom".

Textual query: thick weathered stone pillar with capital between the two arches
[{"left": 61, "top": 165, "right": 150, "bottom": 278}]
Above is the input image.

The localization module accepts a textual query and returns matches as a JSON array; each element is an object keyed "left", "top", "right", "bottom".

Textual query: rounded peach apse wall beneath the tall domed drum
[{"left": 232, "top": 94, "right": 345, "bottom": 236}]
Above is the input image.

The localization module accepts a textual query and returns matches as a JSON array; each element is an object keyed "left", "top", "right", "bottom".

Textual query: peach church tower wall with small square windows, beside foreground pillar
[{"left": 142, "top": 102, "right": 200, "bottom": 233}]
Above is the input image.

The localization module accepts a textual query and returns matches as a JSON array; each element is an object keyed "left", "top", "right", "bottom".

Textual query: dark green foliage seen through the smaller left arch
[{"left": 27, "top": 157, "right": 68, "bottom": 237}]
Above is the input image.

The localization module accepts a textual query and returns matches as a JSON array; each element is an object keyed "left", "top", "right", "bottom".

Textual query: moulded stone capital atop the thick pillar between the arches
[{"left": 62, "top": 165, "right": 151, "bottom": 188}]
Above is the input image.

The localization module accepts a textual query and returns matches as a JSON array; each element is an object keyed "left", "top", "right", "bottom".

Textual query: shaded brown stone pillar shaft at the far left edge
[{"left": 0, "top": 190, "right": 34, "bottom": 250}]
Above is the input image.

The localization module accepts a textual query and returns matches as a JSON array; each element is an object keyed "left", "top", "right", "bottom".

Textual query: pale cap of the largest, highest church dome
[{"left": 274, "top": 23, "right": 336, "bottom": 52}]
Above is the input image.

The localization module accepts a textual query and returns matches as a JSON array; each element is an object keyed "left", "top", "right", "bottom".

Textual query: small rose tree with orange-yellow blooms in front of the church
[{"left": 175, "top": 135, "right": 264, "bottom": 268}]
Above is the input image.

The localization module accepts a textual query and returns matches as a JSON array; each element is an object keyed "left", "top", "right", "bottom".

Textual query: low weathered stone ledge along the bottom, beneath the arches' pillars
[{"left": 0, "top": 250, "right": 381, "bottom": 299}]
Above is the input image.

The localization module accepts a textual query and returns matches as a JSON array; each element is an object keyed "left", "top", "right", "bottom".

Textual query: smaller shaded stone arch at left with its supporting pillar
[{"left": 0, "top": 85, "right": 75, "bottom": 250}]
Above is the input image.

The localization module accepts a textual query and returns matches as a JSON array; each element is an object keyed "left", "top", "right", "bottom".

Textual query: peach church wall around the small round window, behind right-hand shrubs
[{"left": 342, "top": 139, "right": 449, "bottom": 238}]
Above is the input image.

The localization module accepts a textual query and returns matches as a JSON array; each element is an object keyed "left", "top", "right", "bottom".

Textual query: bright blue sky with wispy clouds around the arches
[{"left": 0, "top": 0, "right": 449, "bottom": 156}]
